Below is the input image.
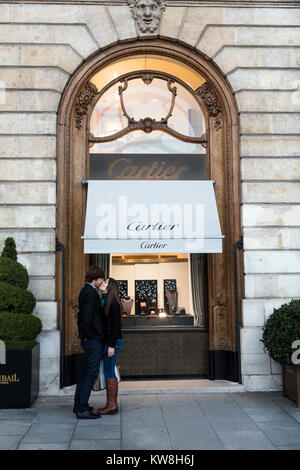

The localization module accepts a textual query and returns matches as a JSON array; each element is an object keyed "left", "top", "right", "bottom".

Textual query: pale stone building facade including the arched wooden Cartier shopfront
[{"left": 0, "top": 0, "right": 300, "bottom": 395}]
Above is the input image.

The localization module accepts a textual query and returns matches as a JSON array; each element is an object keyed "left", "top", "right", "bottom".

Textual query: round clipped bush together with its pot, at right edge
[{"left": 261, "top": 299, "right": 300, "bottom": 407}]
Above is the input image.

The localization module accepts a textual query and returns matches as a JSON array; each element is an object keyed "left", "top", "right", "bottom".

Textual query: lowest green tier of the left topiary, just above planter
[{"left": 0, "top": 312, "right": 42, "bottom": 349}]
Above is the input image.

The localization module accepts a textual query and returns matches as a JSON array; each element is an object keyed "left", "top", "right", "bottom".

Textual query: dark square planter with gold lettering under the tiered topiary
[{"left": 0, "top": 343, "right": 40, "bottom": 408}]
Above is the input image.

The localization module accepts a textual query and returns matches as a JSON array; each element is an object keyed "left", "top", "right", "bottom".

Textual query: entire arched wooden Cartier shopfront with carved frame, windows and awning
[{"left": 57, "top": 40, "right": 239, "bottom": 385}]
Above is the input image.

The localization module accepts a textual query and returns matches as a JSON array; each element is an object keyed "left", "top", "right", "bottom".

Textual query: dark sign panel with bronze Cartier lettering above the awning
[{"left": 89, "top": 153, "right": 206, "bottom": 180}]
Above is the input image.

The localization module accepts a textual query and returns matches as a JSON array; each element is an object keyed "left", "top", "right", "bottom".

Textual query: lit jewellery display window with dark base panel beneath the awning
[{"left": 110, "top": 254, "right": 209, "bottom": 377}]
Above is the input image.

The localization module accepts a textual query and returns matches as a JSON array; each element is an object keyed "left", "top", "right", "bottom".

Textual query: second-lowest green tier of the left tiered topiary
[{"left": 0, "top": 282, "right": 36, "bottom": 314}]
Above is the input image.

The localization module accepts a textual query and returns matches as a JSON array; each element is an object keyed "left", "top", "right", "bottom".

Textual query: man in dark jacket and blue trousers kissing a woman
[{"left": 73, "top": 266, "right": 105, "bottom": 419}]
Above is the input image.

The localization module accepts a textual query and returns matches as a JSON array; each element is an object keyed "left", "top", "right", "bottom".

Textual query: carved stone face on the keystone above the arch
[{"left": 128, "top": 0, "right": 166, "bottom": 36}]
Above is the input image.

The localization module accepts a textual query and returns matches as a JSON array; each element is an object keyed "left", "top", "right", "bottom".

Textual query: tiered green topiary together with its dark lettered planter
[{"left": 0, "top": 237, "right": 42, "bottom": 408}]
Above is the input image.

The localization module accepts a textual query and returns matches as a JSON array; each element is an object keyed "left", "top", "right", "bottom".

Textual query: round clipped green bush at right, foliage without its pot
[{"left": 260, "top": 299, "right": 300, "bottom": 366}]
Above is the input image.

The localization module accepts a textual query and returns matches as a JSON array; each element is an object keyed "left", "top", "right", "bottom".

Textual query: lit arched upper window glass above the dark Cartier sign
[{"left": 90, "top": 56, "right": 205, "bottom": 154}]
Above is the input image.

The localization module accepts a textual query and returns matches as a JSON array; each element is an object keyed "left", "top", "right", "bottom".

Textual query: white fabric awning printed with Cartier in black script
[{"left": 83, "top": 180, "right": 223, "bottom": 253}]
